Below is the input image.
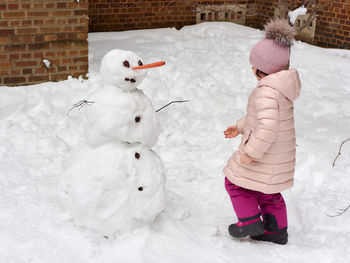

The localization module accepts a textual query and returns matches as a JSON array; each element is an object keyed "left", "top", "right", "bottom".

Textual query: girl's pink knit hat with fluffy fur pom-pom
[{"left": 249, "top": 19, "right": 295, "bottom": 74}]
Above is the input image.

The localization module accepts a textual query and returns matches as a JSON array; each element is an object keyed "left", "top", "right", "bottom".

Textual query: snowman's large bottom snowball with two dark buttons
[{"left": 60, "top": 143, "right": 165, "bottom": 236}]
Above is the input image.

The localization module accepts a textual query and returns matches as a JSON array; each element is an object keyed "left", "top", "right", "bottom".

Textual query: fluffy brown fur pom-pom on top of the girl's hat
[{"left": 265, "top": 19, "right": 296, "bottom": 47}]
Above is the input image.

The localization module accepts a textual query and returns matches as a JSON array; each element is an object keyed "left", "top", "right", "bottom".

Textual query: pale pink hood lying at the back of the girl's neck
[{"left": 258, "top": 69, "right": 301, "bottom": 101}]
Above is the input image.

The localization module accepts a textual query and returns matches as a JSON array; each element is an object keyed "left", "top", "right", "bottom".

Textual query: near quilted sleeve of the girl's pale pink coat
[{"left": 243, "top": 87, "right": 279, "bottom": 159}]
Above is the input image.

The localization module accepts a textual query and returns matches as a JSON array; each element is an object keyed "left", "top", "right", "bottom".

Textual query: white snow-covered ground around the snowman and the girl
[{"left": 0, "top": 23, "right": 350, "bottom": 263}]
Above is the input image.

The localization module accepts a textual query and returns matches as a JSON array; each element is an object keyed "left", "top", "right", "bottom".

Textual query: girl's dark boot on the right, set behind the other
[{"left": 251, "top": 214, "right": 288, "bottom": 245}]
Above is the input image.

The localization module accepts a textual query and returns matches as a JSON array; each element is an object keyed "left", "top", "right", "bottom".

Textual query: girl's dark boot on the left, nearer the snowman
[{"left": 228, "top": 218, "right": 264, "bottom": 237}]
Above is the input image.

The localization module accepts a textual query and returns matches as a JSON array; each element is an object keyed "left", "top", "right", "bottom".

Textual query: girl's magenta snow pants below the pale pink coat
[{"left": 225, "top": 177, "right": 288, "bottom": 229}]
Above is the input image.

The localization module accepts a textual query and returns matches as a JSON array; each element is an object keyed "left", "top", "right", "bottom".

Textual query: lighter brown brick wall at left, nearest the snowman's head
[{"left": 0, "top": 0, "right": 88, "bottom": 86}]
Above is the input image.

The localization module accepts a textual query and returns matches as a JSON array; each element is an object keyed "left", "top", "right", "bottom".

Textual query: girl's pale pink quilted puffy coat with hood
[{"left": 224, "top": 69, "right": 300, "bottom": 194}]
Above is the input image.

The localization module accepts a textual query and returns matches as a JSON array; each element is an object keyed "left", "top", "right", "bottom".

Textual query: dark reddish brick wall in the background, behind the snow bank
[{"left": 89, "top": 0, "right": 350, "bottom": 49}]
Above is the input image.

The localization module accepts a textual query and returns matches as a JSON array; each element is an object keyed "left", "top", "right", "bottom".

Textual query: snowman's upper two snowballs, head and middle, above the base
[{"left": 85, "top": 49, "right": 160, "bottom": 147}]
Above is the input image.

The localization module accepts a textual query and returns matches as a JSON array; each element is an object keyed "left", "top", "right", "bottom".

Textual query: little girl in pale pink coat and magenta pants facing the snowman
[{"left": 224, "top": 20, "right": 300, "bottom": 244}]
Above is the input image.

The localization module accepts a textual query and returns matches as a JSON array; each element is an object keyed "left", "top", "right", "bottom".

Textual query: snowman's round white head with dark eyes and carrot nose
[{"left": 100, "top": 49, "right": 164, "bottom": 91}]
